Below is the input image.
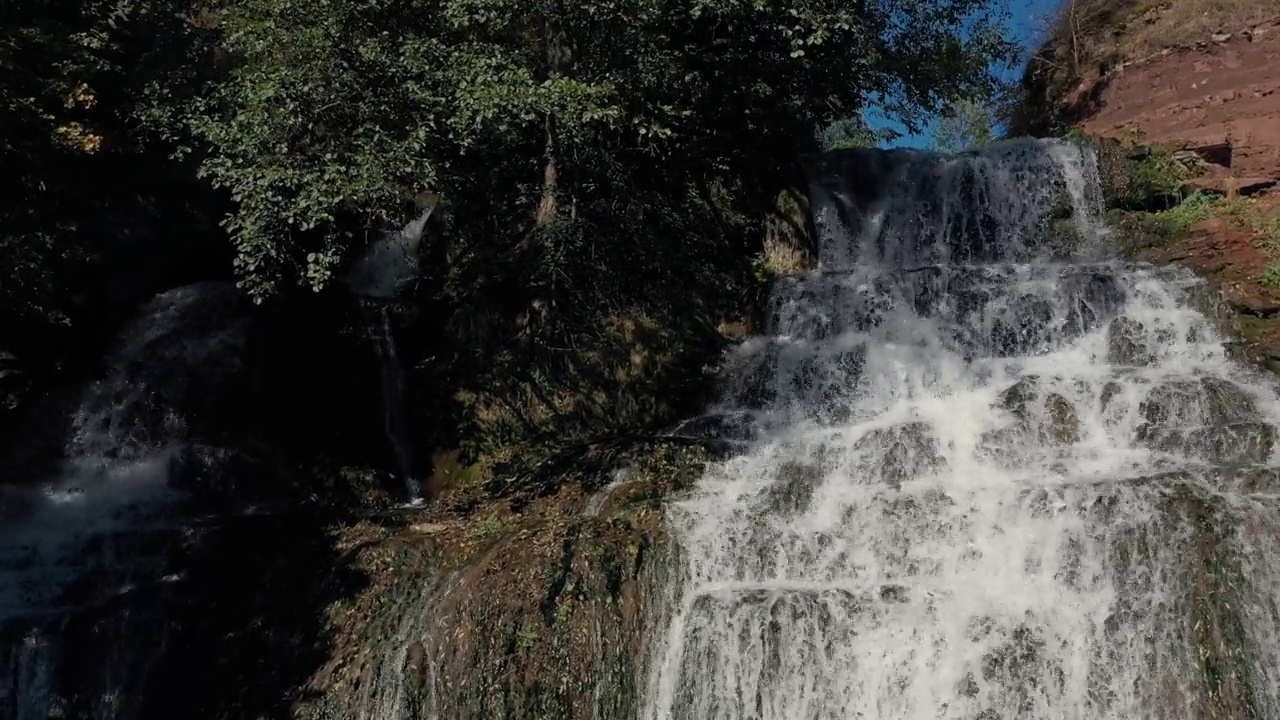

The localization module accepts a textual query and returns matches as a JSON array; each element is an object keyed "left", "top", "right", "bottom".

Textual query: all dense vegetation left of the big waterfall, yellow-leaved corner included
[{"left": 0, "top": 0, "right": 1012, "bottom": 491}]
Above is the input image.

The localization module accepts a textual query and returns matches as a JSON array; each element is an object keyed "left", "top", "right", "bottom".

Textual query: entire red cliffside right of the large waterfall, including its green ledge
[{"left": 1010, "top": 0, "right": 1280, "bottom": 372}]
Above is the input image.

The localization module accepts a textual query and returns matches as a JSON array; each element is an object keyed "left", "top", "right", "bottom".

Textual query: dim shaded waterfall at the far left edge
[{"left": 0, "top": 283, "right": 248, "bottom": 720}]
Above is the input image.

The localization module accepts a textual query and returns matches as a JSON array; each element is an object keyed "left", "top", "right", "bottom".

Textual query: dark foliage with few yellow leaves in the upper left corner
[{"left": 0, "top": 0, "right": 222, "bottom": 386}]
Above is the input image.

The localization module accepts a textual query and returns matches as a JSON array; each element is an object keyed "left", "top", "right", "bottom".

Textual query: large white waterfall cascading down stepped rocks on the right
[{"left": 643, "top": 141, "right": 1280, "bottom": 720}]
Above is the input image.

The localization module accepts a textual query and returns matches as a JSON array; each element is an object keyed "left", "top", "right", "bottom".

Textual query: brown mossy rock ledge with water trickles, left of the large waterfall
[{"left": 294, "top": 435, "right": 713, "bottom": 720}]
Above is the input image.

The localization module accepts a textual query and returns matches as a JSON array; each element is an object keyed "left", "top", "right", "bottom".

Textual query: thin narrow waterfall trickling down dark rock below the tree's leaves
[{"left": 346, "top": 208, "right": 434, "bottom": 503}]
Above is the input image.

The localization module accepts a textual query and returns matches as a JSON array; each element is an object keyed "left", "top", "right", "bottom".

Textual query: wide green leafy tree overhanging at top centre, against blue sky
[{"left": 183, "top": 0, "right": 1011, "bottom": 296}]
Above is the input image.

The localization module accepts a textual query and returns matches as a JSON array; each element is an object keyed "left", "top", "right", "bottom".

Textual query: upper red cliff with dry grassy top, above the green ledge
[{"left": 1012, "top": 0, "right": 1280, "bottom": 188}]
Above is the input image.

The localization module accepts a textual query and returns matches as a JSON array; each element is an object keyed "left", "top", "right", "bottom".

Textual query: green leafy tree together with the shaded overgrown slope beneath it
[{"left": 165, "top": 0, "right": 1012, "bottom": 479}]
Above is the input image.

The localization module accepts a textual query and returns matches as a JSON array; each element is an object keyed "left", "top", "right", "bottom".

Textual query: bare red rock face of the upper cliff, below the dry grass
[{"left": 1084, "top": 20, "right": 1280, "bottom": 181}]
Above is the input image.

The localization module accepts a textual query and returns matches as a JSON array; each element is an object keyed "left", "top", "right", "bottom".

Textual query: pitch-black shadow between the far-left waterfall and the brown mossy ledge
[{"left": 138, "top": 511, "right": 367, "bottom": 720}]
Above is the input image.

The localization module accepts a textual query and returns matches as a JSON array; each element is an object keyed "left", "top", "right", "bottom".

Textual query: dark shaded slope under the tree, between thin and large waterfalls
[{"left": 404, "top": 158, "right": 780, "bottom": 496}]
